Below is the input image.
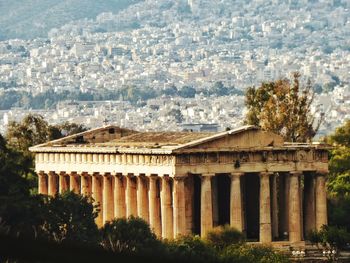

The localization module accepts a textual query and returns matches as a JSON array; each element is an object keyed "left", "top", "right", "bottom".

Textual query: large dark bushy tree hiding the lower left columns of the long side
[{"left": 41, "top": 192, "right": 98, "bottom": 245}]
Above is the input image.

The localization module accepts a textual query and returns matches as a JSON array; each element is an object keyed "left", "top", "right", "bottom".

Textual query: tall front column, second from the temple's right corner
[{"left": 289, "top": 171, "right": 302, "bottom": 242}]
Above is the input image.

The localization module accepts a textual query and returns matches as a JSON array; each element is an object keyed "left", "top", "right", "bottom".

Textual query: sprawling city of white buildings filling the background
[{"left": 0, "top": 0, "right": 350, "bottom": 136}]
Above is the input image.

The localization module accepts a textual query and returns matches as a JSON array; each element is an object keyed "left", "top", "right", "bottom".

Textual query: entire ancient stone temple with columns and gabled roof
[{"left": 31, "top": 126, "right": 328, "bottom": 243}]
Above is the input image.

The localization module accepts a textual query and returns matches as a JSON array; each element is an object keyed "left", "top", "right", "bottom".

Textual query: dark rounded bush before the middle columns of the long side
[{"left": 101, "top": 217, "right": 161, "bottom": 254}]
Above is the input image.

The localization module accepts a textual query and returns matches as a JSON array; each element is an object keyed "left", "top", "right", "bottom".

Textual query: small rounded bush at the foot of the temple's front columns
[{"left": 207, "top": 225, "right": 245, "bottom": 250}]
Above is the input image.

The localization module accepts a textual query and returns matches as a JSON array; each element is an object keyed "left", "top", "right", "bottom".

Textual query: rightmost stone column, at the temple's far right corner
[{"left": 316, "top": 172, "right": 328, "bottom": 230}]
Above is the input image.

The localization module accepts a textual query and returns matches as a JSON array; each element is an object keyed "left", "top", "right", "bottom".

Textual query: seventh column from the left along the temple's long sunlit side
[{"left": 103, "top": 173, "right": 114, "bottom": 224}]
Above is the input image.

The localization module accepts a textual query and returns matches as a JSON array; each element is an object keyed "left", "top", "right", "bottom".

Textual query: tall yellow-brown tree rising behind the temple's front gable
[{"left": 245, "top": 73, "right": 322, "bottom": 142}]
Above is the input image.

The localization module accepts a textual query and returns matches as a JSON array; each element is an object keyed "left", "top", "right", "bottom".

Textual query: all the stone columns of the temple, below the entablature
[{"left": 39, "top": 171, "right": 327, "bottom": 243}]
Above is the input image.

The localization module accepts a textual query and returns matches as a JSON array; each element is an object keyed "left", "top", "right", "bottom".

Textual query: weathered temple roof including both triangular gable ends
[{"left": 30, "top": 125, "right": 328, "bottom": 154}]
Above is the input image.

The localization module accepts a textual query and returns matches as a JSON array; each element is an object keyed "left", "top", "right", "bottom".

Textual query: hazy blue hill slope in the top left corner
[{"left": 0, "top": 0, "right": 141, "bottom": 40}]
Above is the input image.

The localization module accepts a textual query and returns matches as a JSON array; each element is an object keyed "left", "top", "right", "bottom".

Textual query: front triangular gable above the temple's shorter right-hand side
[{"left": 176, "top": 126, "right": 284, "bottom": 151}]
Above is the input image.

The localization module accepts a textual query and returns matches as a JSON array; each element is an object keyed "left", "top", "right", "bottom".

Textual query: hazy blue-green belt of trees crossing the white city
[{"left": 0, "top": 82, "right": 244, "bottom": 110}]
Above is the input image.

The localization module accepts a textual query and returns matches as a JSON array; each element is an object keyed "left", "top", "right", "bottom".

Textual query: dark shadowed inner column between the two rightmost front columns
[{"left": 304, "top": 173, "right": 316, "bottom": 234}]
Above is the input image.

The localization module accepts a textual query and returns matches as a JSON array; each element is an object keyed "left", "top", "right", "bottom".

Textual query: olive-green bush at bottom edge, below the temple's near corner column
[{"left": 166, "top": 236, "right": 219, "bottom": 263}]
